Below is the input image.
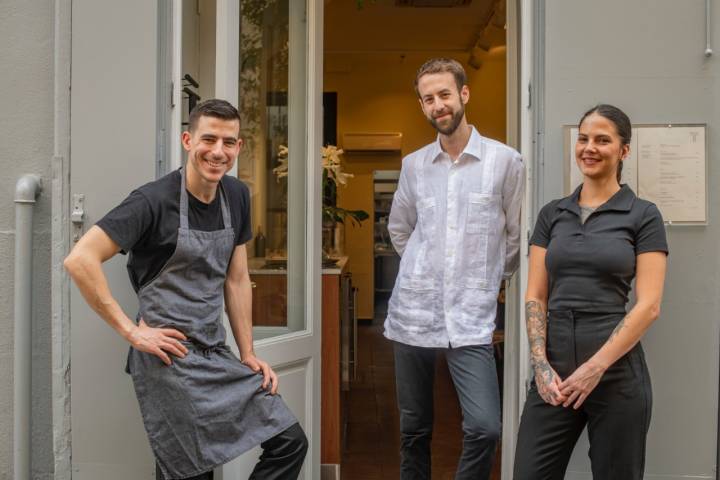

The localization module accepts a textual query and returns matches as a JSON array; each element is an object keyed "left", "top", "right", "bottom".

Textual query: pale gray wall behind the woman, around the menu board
[{"left": 542, "top": 0, "right": 720, "bottom": 479}]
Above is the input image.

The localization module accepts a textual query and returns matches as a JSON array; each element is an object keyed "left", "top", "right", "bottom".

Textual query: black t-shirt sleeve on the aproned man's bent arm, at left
[{"left": 96, "top": 190, "right": 153, "bottom": 253}]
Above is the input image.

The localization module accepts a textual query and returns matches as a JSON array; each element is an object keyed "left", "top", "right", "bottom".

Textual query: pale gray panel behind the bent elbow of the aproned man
[{"left": 70, "top": 0, "right": 158, "bottom": 474}]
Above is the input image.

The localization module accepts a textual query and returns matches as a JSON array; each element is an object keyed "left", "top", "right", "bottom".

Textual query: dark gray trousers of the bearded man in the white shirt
[{"left": 394, "top": 342, "right": 500, "bottom": 480}]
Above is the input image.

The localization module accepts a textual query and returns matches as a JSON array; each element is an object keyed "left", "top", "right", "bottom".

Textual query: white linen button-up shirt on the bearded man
[{"left": 385, "top": 127, "right": 525, "bottom": 347}]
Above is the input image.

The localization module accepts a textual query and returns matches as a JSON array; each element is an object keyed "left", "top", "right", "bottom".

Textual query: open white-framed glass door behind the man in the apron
[{"left": 171, "top": 0, "right": 323, "bottom": 480}]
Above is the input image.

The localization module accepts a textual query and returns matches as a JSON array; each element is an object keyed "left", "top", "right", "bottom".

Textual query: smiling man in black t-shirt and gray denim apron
[{"left": 65, "top": 100, "right": 308, "bottom": 480}]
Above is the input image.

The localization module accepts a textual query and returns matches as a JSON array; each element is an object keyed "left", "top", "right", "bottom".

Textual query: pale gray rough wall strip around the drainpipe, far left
[{"left": 0, "top": 0, "right": 54, "bottom": 480}]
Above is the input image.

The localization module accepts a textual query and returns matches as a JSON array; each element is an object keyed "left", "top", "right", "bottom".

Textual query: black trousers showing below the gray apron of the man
[{"left": 155, "top": 423, "right": 308, "bottom": 480}]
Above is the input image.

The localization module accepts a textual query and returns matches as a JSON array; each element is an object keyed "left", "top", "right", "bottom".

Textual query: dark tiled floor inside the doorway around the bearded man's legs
[{"left": 341, "top": 304, "right": 500, "bottom": 480}]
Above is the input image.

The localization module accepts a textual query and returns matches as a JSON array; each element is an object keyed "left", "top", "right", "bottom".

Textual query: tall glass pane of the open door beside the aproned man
[{"left": 238, "top": 0, "right": 307, "bottom": 339}]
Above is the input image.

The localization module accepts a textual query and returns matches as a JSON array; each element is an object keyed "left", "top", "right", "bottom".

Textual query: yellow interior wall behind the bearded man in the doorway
[{"left": 324, "top": 48, "right": 506, "bottom": 319}]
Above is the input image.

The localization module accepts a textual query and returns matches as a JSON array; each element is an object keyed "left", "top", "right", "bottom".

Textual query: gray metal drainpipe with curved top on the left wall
[{"left": 13, "top": 175, "right": 42, "bottom": 480}]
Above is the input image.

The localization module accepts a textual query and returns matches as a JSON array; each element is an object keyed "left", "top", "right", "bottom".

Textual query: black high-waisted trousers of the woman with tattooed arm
[{"left": 513, "top": 311, "right": 652, "bottom": 480}]
